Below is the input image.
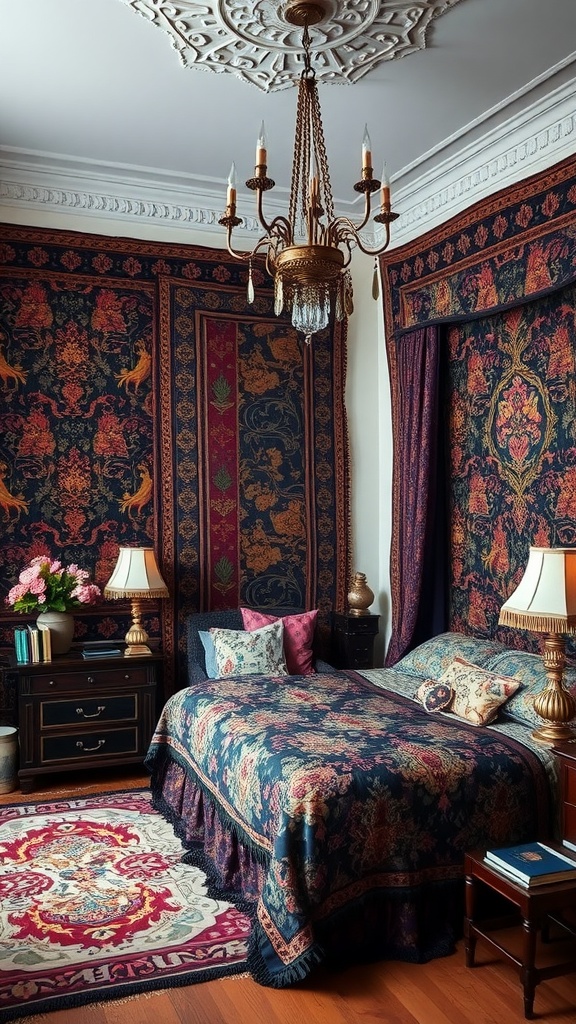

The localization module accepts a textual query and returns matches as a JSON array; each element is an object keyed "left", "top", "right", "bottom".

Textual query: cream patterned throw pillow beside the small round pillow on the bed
[{"left": 432, "top": 657, "right": 520, "bottom": 725}]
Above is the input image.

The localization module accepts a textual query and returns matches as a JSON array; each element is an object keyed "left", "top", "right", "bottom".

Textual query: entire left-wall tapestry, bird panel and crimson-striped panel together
[{"left": 0, "top": 225, "right": 349, "bottom": 694}]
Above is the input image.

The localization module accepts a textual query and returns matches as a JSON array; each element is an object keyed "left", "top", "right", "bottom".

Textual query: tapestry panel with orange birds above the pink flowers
[{"left": 0, "top": 271, "right": 154, "bottom": 637}]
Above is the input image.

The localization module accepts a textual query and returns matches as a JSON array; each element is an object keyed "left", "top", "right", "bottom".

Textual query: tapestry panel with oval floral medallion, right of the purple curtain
[{"left": 448, "top": 285, "right": 576, "bottom": 650}]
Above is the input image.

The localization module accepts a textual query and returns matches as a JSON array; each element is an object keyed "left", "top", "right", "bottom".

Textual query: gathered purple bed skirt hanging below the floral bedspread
[{"left": 149, "top": 750, "right": 464, "bottom": 988}]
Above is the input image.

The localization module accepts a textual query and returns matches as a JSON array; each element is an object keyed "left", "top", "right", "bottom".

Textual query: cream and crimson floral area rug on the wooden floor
[{"left": 0, "top": 790, "right": 250, "bottom": 1021}]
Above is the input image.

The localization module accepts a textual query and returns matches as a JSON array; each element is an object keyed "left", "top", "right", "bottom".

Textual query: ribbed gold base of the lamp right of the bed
[{"left": 532, "top": 633, "right": 576, "bottom": 746}]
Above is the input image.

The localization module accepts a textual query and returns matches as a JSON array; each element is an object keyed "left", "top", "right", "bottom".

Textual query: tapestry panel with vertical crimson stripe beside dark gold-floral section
[{"left": 160, "top": 283, "right": 348, "bottom": 679}]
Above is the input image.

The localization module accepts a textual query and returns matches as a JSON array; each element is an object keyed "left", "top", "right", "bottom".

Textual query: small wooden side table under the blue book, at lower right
[{"left": 464, "top": 851, "right": 576, "bottom": 1020}]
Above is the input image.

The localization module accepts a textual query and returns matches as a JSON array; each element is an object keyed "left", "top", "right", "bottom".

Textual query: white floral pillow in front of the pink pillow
[{"left": 210, "top": 622, "right": 288, "bottom": 678}]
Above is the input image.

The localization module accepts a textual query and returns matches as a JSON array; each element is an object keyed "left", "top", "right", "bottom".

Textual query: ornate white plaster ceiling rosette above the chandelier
[{"left": 122, "top": 0, "right": 459, "bottom": 92}]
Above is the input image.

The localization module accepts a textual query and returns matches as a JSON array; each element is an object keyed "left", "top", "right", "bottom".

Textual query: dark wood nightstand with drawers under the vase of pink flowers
[{"left": 12, "top": 652, "right": 162, "bottom": 793}]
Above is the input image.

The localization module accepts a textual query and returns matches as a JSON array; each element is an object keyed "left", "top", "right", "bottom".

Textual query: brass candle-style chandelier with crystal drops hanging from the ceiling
[{"left": 218, "top": 0, "right": 398, "bottom": 343}]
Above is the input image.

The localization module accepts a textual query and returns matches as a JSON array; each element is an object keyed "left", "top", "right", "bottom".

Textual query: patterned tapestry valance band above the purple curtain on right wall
[{"left": 380, "top": 158, "right": 576, "bottom": 338}]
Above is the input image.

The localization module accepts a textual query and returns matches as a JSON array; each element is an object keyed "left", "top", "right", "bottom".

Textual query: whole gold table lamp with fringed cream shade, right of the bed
[{"left": 499, "top": 548, "right": 576, "bottom": 744}]
